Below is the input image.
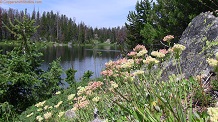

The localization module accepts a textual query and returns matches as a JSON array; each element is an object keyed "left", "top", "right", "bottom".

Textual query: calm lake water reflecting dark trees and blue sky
[{"left": 0, "top": 46, "right": 120, "bottom": 81}]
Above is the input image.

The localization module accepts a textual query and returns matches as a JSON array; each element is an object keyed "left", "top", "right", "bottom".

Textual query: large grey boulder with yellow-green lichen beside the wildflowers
[{"left": 162, "top": 12, "right": 218, "bottom": 79}]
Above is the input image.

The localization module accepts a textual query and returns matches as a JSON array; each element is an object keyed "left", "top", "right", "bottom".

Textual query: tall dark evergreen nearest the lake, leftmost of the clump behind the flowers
[{"left": 126, "top": 0, "right": 153, "bottom": 48}]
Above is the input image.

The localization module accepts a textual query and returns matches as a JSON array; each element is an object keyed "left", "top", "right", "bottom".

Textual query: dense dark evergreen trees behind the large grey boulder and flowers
[{"left": 126, "top": 0, "right": 218, "bottom": 50}]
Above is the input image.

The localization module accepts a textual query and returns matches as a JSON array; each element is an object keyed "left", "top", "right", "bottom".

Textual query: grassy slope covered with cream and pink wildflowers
[{"left": 20, "top": 36, "right": 217, "bottom": 122}]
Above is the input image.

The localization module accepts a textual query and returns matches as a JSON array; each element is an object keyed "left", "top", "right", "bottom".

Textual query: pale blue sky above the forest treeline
[{"left": 0, "top": 0, "right": 137, "bottom": 28}]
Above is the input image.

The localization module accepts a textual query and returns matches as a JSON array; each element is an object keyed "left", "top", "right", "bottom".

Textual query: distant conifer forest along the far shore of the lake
[{"left": 0, "top": 8, "right": 126, "bottom": 44}]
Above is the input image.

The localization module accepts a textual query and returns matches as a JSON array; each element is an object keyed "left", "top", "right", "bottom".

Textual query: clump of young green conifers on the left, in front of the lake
[{"left": 0, "top": 13, "right": 62, "bottom": 121}]
